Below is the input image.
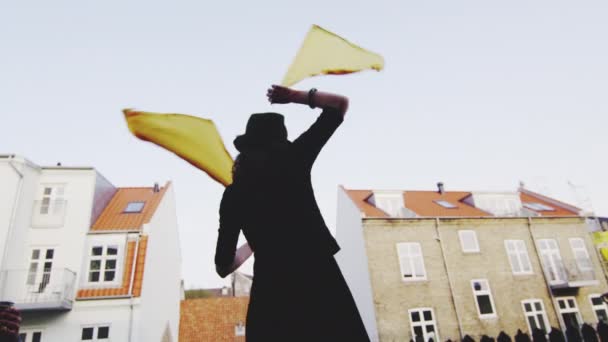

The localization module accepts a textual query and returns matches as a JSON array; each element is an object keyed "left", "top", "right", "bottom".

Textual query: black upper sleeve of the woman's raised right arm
[{"left": 293, "top": 108, "right": 344, "bottom": 169}]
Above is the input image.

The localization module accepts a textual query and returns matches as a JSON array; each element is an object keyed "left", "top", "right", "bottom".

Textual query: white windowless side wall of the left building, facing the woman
[{"left": 136, "top": 186, "right": 181, "bottom": 342}]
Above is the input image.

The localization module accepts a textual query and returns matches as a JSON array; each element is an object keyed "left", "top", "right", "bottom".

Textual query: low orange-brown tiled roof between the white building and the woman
[{"left": 179, "top": 297, "right": 249, "bottom": 342}]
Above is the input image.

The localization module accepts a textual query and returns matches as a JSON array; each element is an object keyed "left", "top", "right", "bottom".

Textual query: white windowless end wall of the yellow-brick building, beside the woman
[{"left": 336, "top": 187, "right": 378, "bottom": 341}]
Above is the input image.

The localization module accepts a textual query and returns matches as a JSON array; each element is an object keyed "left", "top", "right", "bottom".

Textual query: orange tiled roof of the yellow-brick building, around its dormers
[{"left": 342, "top": 187, "right": 580, "bottom": 218}]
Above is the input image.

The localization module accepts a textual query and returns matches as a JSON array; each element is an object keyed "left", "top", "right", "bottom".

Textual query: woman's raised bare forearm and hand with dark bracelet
[{"left": 266, "top": 85, "right": 348, "bottom": 117}]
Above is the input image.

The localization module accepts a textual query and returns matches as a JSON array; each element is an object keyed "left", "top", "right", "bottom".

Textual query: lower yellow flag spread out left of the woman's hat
[{"left": 123, "top": 109, "right": 233, "bottom": 186}]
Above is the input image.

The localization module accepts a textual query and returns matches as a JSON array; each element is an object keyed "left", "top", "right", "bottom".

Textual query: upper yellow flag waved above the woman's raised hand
[{"left": 281, "top": 25, "right": 384, "bottom": 87}]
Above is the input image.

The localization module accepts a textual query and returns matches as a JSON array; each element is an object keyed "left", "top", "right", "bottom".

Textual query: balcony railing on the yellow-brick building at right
[{"left": 544, "top": 259, "right": 599, "bottom": 289}]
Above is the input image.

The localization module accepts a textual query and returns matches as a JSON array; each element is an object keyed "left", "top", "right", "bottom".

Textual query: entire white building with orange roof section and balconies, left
[{"left": 0, "top": 155, "right": 182, "bottom": 342}]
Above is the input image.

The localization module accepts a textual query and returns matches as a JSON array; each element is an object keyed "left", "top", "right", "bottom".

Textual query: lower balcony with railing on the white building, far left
[{"left": 0, "top": 268, "right": 76, "bottom": 311}]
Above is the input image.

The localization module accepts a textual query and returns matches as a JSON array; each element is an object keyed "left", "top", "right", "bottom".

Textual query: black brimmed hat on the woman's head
[{"left": 234, "top": 113, "right": 290, "bottom": 152}]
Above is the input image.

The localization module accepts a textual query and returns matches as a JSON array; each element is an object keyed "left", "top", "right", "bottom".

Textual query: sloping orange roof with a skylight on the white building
[{"left": 91, "top": 182, "right": 171, "bottom": 231}]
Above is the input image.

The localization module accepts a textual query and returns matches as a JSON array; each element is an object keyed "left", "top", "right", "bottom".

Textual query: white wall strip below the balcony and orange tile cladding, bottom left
[{"left": 21, "top": 299, "right": 137, "bottom": 342}]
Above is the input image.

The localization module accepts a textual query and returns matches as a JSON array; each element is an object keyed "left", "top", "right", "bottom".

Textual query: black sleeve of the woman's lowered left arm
[{"left": 215, "top": 187, "right": 241, "bottom": 267}]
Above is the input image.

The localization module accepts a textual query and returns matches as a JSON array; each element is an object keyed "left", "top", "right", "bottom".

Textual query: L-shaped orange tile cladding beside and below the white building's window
[{"left": 76, "top": 235, "right": 148, "bottom": 299}]
